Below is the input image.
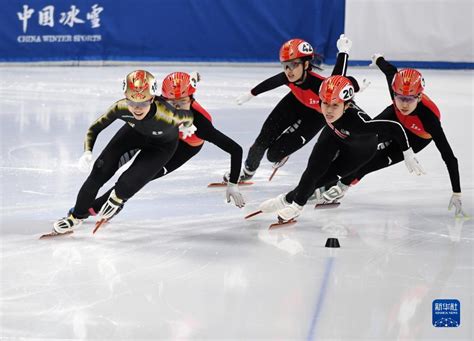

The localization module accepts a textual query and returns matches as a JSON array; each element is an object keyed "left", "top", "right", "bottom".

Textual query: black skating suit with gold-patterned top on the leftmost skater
[{"left": 73, "top": 97, "right": 193, "bottom": 218}]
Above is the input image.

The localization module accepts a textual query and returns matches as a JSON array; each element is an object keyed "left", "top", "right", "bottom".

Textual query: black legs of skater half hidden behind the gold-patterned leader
[{"left": 91, "top": 140, "right": 203, "bottom": 212}]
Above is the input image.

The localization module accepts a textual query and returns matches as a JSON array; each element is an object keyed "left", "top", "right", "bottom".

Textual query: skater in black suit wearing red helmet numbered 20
[{"left": 260, "top": 76, "right": 423, "bottom": 223}]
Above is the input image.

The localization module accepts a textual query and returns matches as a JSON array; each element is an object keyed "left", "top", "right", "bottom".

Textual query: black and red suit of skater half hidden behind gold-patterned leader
[{"left": 92, "top": 100, "right": 242, "bottom": 212}]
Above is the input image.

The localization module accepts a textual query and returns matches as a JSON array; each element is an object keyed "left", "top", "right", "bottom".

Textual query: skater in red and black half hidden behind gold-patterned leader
[{"left": 90, "top": 72, "right": 245, "bottom": 214}]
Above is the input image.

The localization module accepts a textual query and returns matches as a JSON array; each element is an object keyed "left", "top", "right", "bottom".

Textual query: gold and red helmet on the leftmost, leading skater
[{"left": 123, "top": 70, "right": 157, "bottom": 102}]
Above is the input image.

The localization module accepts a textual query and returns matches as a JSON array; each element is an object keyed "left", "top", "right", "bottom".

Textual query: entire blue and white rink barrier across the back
[{"left": 0, "top": 0, "right": 474, "bottom": 69}]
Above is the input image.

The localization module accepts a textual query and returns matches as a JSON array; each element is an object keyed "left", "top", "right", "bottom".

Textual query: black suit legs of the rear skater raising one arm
[{"left": 245, "top": 92, "right": 325, "bottom": 171}]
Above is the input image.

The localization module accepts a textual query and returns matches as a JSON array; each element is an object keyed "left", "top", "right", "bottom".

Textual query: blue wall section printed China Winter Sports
[{"left": 0, "top": 0, "right": 345, "bottom": 62}]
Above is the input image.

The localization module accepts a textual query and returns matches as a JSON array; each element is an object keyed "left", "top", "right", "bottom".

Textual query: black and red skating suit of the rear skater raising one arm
[{"left": 245, "top": 53, "right": 348, "bottom": 171}]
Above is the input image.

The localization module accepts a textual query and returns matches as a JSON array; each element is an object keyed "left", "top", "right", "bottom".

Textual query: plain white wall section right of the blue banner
[{"left": 345, "top": 0, "right": 474, "bottom": 62}]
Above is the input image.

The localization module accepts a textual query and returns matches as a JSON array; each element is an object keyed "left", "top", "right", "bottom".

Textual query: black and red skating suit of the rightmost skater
[{"left": 342, "top": 57, "right": 461, "bottom": 193}]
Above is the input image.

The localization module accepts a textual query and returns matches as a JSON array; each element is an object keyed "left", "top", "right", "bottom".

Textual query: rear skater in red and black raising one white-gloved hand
[{"left": 228, "top": 35, "right": 352, "bottom": 180}]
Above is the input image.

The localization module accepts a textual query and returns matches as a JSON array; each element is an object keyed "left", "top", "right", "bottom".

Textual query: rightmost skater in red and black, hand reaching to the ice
[{"left": 323, "top": 53, "right": 466, "bottom": 216}]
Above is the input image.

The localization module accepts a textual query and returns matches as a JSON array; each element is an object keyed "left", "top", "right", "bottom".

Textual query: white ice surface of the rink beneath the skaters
[{"left": 0, "top": 65, "right": 474, "bottom": 340}]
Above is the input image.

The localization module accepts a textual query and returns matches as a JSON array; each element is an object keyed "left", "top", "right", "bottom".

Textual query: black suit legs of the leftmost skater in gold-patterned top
[{"left": 74, "top": 124, "right": 178, "bottom": 218}]
